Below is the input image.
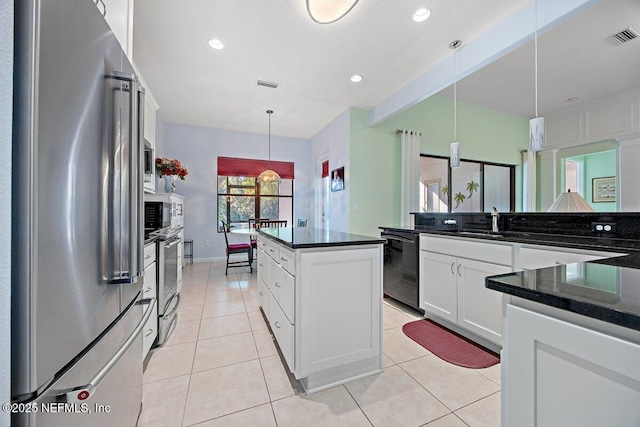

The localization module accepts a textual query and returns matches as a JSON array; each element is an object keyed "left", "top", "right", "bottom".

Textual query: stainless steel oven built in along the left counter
[{"left": 158, "top": 230, "right": 180, "bottom": 345}]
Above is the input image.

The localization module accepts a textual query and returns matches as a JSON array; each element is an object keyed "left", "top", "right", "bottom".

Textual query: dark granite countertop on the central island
[{"left": 258, "top": 227, "right": 385, "bottom": 249}]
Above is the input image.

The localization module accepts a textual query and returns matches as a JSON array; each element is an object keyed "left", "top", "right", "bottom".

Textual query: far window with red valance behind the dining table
[{"left": 217, "top": 157, "right": 294, "bottom": 232}]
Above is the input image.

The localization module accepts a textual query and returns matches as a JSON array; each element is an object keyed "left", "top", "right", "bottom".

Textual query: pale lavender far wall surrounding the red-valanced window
[{"left": 156, "top": 123, "right": 312, "bottom": 261}]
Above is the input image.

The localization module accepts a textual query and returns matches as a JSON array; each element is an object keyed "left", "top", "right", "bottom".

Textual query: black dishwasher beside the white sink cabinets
[{"left": 380, "top": 229, "right": 424, "bottom": 313}]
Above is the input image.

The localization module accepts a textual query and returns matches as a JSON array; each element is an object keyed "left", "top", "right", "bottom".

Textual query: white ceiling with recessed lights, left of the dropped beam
[{"left": 133, "top": 0, "right": 528, "bottom": 139}]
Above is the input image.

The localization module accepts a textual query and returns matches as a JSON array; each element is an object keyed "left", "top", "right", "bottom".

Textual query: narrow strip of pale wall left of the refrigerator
[{"left": 0, "top": 0, "right": 13, "bottom": 426}]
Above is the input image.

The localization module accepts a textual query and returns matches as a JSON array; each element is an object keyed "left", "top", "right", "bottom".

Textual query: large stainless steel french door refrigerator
[{"left": 11, "top": 0, "right": 155, "bottom": 427}]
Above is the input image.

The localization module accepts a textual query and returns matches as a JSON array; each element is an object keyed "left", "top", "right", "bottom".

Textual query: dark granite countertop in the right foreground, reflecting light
[{"left": 485, "top": 254, "right": 640, "bottom": 331}]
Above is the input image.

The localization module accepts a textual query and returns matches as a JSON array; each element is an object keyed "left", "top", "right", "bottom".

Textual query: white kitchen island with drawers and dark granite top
[{"left": 258, "top": 227, "right": 384, "bottom": 393}]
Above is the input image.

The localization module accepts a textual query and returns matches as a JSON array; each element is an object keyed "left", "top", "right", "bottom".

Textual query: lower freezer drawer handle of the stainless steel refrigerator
[{"left": 56, "top": 298, "right": 156, "bottom": 403}]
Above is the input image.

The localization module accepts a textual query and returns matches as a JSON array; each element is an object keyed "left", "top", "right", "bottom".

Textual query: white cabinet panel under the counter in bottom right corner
[{"left": 502, "top": 304, "right": 640, "bottom": 427}]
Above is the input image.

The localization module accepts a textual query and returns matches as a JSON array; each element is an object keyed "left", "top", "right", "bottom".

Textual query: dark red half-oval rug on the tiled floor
[{"left": 402, "top": 319, "right": 500, "bottom": 369}]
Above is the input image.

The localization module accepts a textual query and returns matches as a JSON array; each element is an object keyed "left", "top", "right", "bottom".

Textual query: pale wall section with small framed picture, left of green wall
[{"left": 309, "top": 110, "right": 351, "bottom": 232}]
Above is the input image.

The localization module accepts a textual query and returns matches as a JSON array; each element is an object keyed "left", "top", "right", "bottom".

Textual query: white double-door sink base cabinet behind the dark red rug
[{"left": 420, "top": 242, "right": 511, "bottom": 345}]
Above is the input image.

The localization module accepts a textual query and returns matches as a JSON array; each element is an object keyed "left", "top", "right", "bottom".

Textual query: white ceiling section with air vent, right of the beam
[{"left": 441, "top": 0, "right": 640, "bottom": 117}]
